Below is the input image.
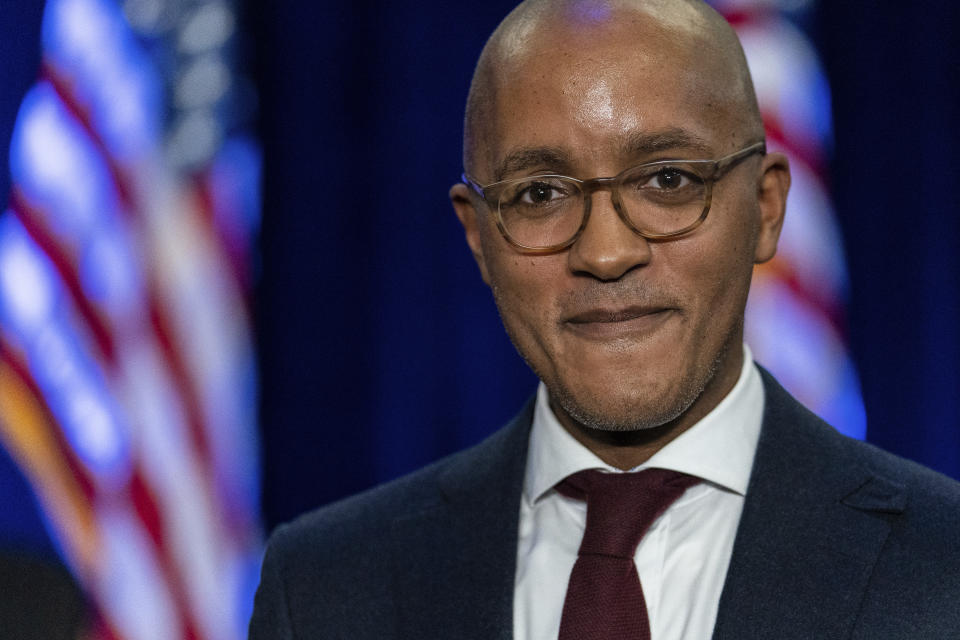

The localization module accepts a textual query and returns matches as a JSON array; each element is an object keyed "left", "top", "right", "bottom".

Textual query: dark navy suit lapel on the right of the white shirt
[{"left": 713, "top": 372, "right": 905, "bottom": 640}]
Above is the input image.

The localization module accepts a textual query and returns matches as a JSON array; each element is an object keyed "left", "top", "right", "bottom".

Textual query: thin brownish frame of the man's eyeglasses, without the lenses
[{"left": 460, "top": 141, "right": 767, "bottom": 254}]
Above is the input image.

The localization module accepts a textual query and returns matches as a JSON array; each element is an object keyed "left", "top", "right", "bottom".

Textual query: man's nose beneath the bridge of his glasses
[{"left": 568, "top": 191, "right": 651, "bottom": 280}]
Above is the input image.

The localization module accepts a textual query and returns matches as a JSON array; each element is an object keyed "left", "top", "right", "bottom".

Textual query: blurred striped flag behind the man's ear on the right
[{"left": 711, "top": 0, "right": 867, "bottom": 439}]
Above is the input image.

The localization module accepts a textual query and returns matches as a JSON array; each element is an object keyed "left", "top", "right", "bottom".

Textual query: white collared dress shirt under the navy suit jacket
[{"left": 513, "top": 345, "right": 764, "bottom": 640}]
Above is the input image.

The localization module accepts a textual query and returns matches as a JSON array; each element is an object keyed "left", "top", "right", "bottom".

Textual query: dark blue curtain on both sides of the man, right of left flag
[{"left": 251, "top": 0, "right": 960, "bottom": 526}]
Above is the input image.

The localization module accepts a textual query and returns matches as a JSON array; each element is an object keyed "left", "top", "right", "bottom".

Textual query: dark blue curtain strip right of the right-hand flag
[{"left": 818, "top": 0, "right": 960, "bottom": 478}]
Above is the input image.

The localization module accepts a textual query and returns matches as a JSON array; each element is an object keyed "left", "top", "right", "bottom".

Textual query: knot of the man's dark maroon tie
[{"left": 557, "top": 469, "right": 700, "bottom": 558}]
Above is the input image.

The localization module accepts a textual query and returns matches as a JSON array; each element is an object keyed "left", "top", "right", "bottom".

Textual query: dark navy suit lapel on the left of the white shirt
[{"left": 392, "top": 400, "right": 533, "bottom": 640}]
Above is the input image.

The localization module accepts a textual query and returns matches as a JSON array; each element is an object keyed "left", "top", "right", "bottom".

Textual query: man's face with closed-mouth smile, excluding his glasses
[{"left": 452, "top": 16, "right": 782, "bottom": 430}]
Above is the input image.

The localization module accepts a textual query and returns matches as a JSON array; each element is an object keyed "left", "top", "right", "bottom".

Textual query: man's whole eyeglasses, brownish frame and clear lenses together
[{"left": 461, "top": 142, "right": 766, "bottom": 253}]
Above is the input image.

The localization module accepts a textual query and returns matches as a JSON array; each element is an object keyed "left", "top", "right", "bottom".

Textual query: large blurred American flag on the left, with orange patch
[{"left": 0, "top": 0, "right": 261, "bottom": 640}]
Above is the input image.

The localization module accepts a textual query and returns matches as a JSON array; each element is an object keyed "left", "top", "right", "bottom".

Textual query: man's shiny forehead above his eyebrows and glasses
[{"left": 486, "top": 14, "right": 740, "bottom": 178}]
